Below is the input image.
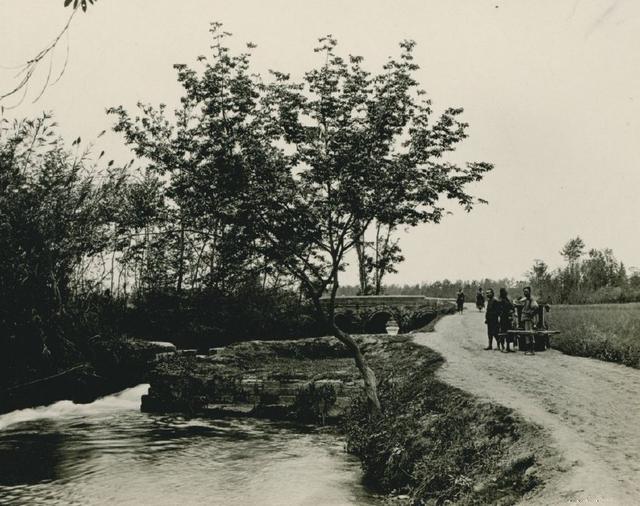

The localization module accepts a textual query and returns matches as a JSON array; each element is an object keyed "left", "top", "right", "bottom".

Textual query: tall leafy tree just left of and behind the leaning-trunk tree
[{"left": 109, "top": 23, "right": 275, "bottom": 293}]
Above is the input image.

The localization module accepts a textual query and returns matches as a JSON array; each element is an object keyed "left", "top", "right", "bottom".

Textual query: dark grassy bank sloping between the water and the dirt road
[{"left": 343, "top": 341, "right": 548, "bottom": 504}]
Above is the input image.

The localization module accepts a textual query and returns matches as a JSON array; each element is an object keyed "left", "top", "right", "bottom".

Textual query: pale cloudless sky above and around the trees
[{"left": 0, "top": 0, "right": 640, "bottom": 284}]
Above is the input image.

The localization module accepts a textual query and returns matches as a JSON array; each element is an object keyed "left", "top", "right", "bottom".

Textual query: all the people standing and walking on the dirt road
[{"left": 456, "top": 286, "right": 538, "bottom": 353}]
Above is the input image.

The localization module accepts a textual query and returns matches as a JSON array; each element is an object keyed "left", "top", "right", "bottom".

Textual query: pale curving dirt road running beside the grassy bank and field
[{"left": 415, "top": 305, "right": 640, "bottom": 505}]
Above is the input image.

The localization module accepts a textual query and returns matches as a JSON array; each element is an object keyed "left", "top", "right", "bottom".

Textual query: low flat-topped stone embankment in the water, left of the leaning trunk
[{"left": 142, "top": 336, "right": 382, "bottom": 423}]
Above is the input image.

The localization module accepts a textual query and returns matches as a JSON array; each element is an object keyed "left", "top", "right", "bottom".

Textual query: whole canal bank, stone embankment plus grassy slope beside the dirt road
[{"left": 143, "top": 335, "right": 549, "bottom": 504}]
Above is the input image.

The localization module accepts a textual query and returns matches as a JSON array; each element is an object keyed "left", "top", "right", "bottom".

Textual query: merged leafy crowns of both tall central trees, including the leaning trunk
[{"left": 109, "top": 23, "right": 492, "bottom": 408}]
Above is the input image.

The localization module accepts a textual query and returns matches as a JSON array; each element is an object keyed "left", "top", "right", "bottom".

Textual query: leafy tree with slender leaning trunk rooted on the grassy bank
[{"left": 245, "top": 36, "right": 491, "bottom": 411}]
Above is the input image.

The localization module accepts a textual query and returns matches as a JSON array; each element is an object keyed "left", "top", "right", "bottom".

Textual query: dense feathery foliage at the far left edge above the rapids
[{"left": 0, "top": 115, "right": 121, "bottom": 322}]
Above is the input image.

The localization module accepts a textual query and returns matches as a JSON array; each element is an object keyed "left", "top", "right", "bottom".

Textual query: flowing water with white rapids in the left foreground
[{"left": 0, "top": 385, "right": 378, "bottom": 506}]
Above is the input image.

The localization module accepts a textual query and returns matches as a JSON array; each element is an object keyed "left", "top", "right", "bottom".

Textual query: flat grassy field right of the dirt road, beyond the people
[{"left": 549, "top": 303, "right": 640, "bottom": 369}]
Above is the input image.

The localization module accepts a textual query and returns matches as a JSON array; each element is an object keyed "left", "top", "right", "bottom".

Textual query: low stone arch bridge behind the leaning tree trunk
[{"left": 322, "top": 295, "right": 455, "bottom": 334}]
